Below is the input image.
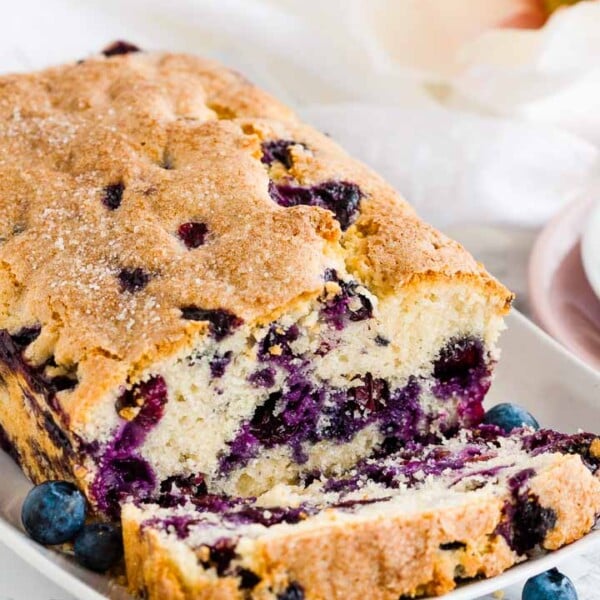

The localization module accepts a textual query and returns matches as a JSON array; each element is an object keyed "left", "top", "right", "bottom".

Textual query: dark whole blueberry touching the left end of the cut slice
[{"left": 73, "top": 523, "right": 123, "bottom": 573}]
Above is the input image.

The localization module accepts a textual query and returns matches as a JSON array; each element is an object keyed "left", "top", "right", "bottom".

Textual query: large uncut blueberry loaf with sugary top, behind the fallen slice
[{"left": 0, "top": 44, "right": 512, "bottom": 514}]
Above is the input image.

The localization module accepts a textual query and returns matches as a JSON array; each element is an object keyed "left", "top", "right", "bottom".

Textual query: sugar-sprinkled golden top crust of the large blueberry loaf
[{"left": 0, "top": 49, "right": 510, "bottom": 422}]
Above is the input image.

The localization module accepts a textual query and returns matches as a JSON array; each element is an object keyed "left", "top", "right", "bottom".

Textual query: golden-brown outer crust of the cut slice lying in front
[{"left": 124, "top": 455, "right": 600, "bottom": 600}]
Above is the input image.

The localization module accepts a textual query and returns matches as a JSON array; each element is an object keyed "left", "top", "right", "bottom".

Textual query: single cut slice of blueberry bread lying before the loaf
[{"left": 123, "top": 426, "right": 600, "bottom": 600}]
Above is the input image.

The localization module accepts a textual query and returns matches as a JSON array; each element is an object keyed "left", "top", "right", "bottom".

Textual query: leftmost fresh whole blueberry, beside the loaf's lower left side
[{"left": 21, "top": 481, "right": 87, "bottom": 545}]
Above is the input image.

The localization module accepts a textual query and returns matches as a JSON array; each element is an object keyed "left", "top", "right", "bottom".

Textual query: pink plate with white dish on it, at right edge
[{"left": 529, "top": 198, "right": 600, "bottom": 369}]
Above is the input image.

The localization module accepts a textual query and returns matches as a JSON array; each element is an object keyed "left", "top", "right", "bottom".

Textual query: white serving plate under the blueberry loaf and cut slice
[{"left": 0, "top": 311, "right": 600, "bottom": 600}]
